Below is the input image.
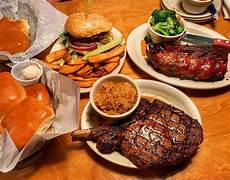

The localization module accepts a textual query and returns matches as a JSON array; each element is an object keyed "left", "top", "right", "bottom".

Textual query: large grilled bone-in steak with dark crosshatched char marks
[{"left": 72, "top": 99, "right": 203, "bottom": 168}]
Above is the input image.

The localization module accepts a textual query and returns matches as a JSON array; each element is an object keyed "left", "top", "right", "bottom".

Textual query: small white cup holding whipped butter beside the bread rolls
[{"left": 11, "top": 60, "right": 43, "bottom": 86}]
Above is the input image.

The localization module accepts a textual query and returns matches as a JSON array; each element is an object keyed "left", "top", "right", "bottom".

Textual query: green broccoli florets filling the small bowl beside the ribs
[{"left": 150, "top": 9, "right": 184, "bottom": 36}]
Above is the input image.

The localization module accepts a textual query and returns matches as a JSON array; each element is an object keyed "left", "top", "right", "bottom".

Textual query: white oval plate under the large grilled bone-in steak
[{"left": 81, "top": 79, "right": 201, "bottom": 168}]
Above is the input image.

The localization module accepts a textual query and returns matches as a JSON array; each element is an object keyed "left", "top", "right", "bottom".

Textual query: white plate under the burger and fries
[{"left": 50, "top": 27, "right": 126, "bottom": 93}]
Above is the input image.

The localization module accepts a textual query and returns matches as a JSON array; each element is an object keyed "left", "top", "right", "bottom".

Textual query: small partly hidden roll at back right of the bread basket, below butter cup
[{"left": 25, "top": 83, "right": 50, "bottom": 105}]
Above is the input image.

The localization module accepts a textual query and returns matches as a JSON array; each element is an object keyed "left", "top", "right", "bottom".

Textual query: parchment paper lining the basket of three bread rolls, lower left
[{"left": 0, "top": 62, "right": 80, "bottom": 172}]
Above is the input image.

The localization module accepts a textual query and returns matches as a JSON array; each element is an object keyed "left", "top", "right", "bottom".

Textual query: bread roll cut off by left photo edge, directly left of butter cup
[{"left": 0, "top": 72, "right": 26, "bottom": 119}]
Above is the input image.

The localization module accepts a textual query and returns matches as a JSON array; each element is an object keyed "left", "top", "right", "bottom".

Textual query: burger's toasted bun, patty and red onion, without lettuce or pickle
[{"left": 65, "top": 13, "right": 112, "bottom": 51}]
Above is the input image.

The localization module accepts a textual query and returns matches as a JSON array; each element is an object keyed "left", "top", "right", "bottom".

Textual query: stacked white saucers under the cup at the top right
[{"left": 161, "top": 0, "right": 221, "bottom": 23}]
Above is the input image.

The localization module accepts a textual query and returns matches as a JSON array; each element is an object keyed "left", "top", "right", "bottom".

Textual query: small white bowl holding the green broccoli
[{"left": 147, "top": 16, "right": 186, "bottom": 43}]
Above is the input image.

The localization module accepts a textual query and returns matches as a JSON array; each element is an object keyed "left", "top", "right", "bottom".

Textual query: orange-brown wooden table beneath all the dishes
[{"left": 0, "top": 0, "right": 230, "bottom": 180}]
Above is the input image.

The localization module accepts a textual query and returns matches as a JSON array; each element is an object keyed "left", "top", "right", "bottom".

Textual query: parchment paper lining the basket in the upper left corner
[{"left": 0, "top": 0, "right": 67, "bottom": 63}]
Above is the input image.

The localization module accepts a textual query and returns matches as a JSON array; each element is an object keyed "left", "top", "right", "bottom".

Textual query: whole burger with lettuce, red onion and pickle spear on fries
[{"left": 61, "top": 13, "right": 123, "bottom": 60}]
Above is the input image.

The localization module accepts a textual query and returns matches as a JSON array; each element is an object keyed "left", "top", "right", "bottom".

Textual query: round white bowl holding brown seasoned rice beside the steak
[{"left": 89, "top": 74, "right": 141, "bottom": 123}]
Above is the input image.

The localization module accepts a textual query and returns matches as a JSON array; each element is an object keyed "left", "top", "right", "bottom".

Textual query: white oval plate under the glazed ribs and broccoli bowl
[{"left": 126, "top": 22, "right": 230, "bottom": 89}]
